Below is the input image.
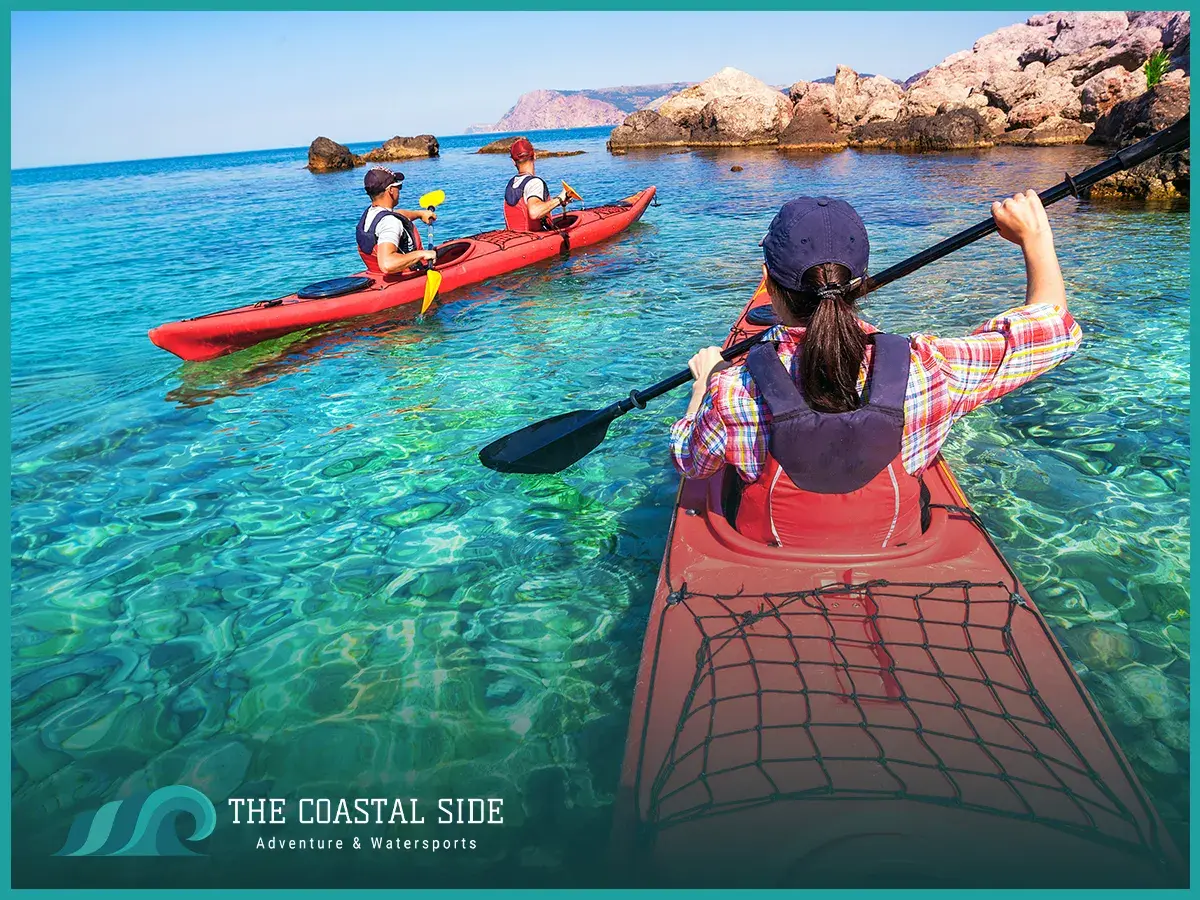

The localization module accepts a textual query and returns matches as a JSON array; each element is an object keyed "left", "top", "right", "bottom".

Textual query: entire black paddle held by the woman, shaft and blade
[{"left": 479, "top": 115, "right": 1190, "bottom": 475}]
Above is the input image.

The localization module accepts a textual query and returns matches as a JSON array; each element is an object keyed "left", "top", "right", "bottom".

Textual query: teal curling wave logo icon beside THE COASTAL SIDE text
[{"left": 54, "top": 785, "right": 217, "bottom": 857}]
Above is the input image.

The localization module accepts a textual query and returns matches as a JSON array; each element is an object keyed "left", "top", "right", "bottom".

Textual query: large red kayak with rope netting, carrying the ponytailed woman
[{"left": 613, "top": 282, "right": 1187, "bottom": 888}]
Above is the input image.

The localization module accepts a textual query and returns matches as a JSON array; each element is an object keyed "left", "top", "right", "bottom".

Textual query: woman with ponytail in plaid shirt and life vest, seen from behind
[{"left": 671, "top": 191, "right": 1082, "bottom": 548}]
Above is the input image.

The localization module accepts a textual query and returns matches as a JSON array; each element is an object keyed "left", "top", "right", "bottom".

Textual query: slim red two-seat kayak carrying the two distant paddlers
[{"left": 150, "top": 187, "right": 654, "bottom": 361}]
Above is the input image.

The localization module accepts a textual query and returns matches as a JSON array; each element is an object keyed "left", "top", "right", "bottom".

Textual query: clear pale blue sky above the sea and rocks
[{"left": 11, "top": 11, "right": 1033, "bottom": 168}]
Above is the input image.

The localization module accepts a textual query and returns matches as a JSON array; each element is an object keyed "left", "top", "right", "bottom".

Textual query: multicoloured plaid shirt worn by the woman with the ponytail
[{"left": 671, "top": 304, "right": 1082, "bottom": 481}]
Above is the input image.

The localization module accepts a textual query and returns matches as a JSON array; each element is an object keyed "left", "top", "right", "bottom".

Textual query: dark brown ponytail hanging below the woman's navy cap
[{"left": 767, "top": 263, "right": 866, "bottom": 413}]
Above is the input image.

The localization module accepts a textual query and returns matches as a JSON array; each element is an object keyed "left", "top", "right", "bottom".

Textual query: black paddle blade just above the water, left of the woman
[{"left": 479, "top": 407, "right": 620, "bottom": 475}]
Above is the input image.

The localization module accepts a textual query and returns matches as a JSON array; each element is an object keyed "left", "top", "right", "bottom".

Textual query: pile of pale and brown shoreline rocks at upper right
[{"left": 608, "top": 12, "right": 1190, "bottom": 197}]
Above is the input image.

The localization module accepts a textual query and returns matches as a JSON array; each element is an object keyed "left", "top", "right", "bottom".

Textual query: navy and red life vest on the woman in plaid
[{"left": 737, "top": 332, "right": 920, "bottom": 551}]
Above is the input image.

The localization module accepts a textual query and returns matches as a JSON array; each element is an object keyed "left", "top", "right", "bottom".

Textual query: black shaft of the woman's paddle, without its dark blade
[{"left": 610, "top": 113, "right": 1192, "bottom": 418}]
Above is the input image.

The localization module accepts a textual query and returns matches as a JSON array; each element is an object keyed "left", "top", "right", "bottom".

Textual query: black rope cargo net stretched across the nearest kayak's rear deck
[{"left": 635, "top": 504, "right": 1170, "bottom": 871}]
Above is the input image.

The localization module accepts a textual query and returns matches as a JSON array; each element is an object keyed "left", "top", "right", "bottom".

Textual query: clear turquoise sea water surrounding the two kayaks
[{"left": 11, "top": 130, "right": 1190, "bottom": 884}]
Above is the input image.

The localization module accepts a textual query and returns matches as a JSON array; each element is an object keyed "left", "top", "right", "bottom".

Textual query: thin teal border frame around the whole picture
[{"left": 0, "top": 0, "right": 1200, "bottom": 900}]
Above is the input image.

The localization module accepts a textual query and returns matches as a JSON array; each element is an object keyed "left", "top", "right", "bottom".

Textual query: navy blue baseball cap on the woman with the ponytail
[{"left": 762, "top": 197, "right": 871, "bottom": 290}]
